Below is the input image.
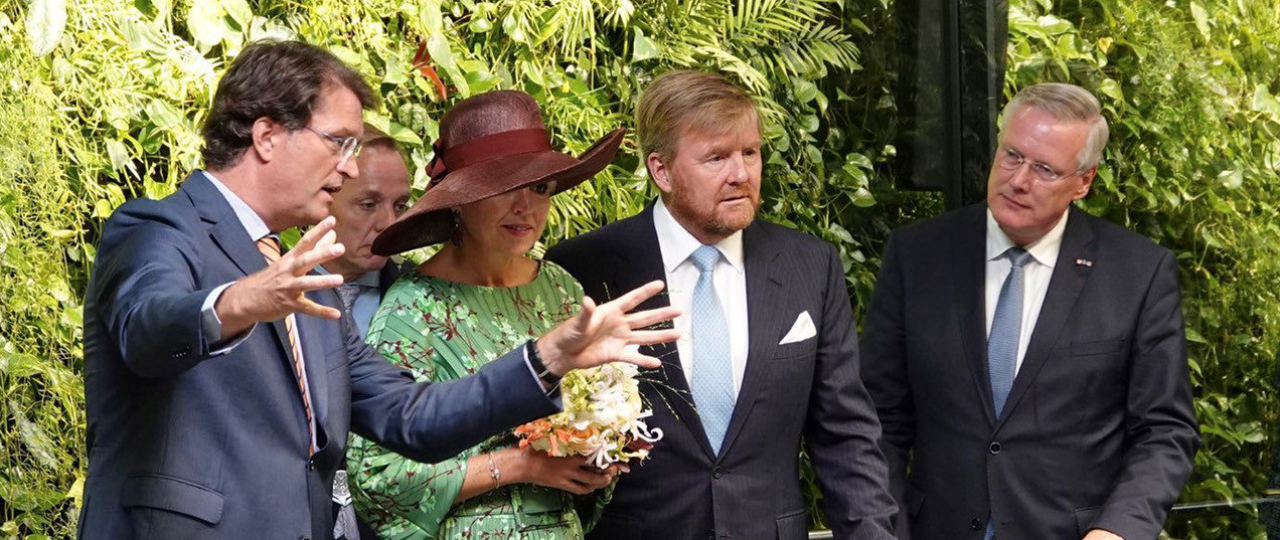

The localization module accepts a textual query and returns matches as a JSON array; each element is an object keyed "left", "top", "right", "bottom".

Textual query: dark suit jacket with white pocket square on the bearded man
[{"left": 547, "top": 206, "right": 893, "bottom": 540}]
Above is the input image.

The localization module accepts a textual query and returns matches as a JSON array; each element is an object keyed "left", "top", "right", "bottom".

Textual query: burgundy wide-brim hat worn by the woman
[{"left": 372, "top": 90, "right": 626, "bottom": 255}]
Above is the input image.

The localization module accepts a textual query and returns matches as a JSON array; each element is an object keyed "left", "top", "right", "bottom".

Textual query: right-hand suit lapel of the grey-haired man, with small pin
[{"left": 996, "top": 206, "right": 1097, "bottom": 430}]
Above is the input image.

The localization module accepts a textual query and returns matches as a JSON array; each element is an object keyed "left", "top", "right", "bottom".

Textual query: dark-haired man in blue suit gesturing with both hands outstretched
[{"left": 79, "top": 41, "right": 677, "bottom": 540}]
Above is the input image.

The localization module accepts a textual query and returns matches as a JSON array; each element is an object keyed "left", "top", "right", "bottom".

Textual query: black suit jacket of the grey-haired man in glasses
[{"left": 861, "top": 205, "right": 1199, "bottom": 540}]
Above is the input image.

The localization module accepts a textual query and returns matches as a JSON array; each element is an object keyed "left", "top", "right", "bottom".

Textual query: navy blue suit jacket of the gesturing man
[{"left": 79, "top": 174, "right": 556, "bottom": 540}]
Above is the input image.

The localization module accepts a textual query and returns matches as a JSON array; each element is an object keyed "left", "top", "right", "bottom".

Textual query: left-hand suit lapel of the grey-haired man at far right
[{"left": 948, "top": 205, "right": 996, "bottom": 426}]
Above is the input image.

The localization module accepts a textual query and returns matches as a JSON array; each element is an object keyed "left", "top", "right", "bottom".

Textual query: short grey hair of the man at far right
[{"left": 1000, "top": 82, "right": 1110, "bottom": 171}]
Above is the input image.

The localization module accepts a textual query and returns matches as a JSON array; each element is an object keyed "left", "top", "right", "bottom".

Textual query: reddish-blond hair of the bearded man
[{"left": 636, "top": 70, "right": 760, "bottom": 160}]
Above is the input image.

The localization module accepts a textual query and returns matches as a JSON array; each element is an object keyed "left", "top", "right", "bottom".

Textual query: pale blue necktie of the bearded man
[{"left": 689, "top": 246, "right": 733, "bottom": 456}]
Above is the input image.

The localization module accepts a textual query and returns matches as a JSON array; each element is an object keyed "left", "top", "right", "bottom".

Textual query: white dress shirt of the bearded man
[{"left": 653, "top": 200, "right": 748, "bottom": 398}]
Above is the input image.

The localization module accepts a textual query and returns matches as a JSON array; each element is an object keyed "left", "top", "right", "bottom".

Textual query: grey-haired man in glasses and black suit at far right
[{"left": 860, "top": 83, "right": 1199, "bottom": 540}]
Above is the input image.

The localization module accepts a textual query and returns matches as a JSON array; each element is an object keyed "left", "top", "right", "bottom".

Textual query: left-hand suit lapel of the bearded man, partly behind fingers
[{"left": 619, "top": 205, "right": 716, "bottom": 459}]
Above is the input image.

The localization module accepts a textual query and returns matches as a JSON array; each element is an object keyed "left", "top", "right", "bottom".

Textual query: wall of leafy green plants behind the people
[{"left": 0, "top": 0, "right": 1280, "bottom": 539}]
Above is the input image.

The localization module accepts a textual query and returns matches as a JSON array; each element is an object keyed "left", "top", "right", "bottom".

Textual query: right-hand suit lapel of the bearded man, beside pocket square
[{"left": 721, "top": 224, "right": 788, "bottom": 456}]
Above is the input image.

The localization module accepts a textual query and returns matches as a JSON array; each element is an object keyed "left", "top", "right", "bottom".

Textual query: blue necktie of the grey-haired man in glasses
[{"left": 983, "top": 247, "right": 1032, "bottom": 540}]
